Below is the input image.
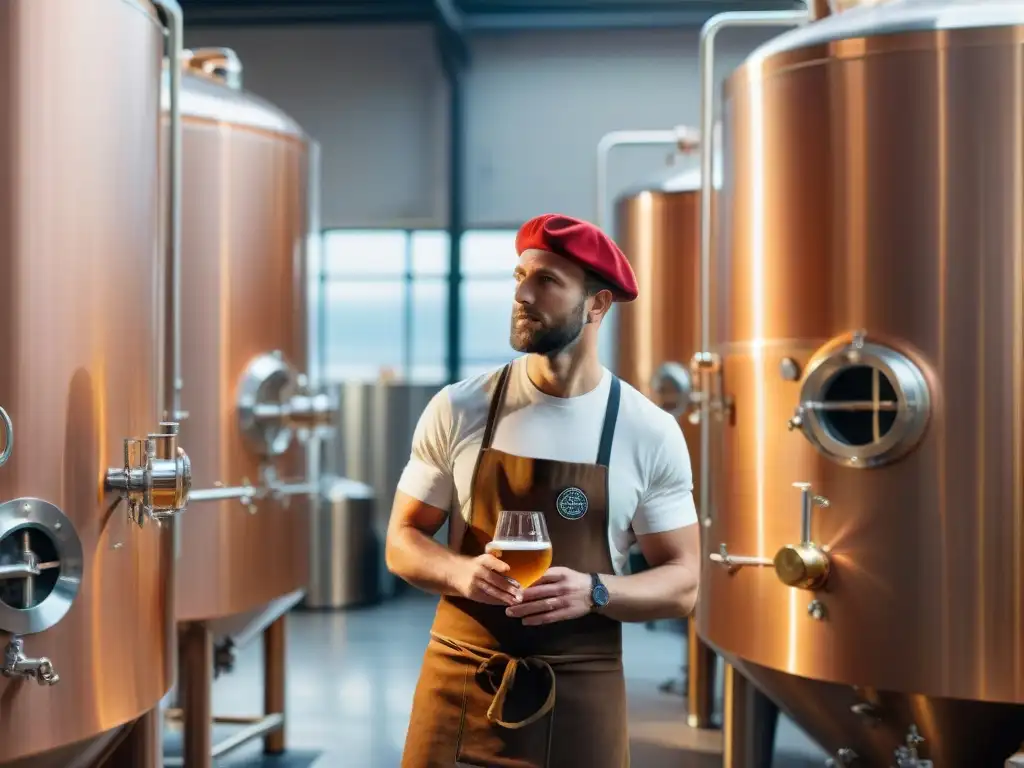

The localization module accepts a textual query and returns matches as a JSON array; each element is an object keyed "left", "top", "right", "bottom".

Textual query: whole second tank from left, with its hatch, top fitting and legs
[{"left": 166, "top": 49, "right": 333, "bottom": 766}]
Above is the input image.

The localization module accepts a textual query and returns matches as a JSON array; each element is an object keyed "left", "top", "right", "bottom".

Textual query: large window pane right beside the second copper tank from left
[{"left": 324, "top": 281, "right": 406, "bottom": 381}]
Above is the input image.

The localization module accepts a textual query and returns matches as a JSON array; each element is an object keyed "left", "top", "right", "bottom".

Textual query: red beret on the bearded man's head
[{"left": 515, "top": 213, "right": 639, "bottom": 301}]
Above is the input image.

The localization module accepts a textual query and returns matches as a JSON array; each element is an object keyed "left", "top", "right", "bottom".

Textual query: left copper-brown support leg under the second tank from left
[{"left": 178, "top": 624, "right": 213, "bottom": 768}]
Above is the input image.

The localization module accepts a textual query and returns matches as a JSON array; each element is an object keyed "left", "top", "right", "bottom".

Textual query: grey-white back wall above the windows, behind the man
[{"left": 185, "top": 27, "right": 767, "bottom": 227}]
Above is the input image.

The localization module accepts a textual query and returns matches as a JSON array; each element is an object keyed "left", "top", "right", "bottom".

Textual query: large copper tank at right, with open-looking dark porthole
[{"left": 698, "top": 0, "right": 1024, "bottom": 768}]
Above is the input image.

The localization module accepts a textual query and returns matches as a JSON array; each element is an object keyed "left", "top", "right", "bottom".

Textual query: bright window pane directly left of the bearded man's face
[{"left": 460, "top": 275, "right": 515, "bottom": 360}]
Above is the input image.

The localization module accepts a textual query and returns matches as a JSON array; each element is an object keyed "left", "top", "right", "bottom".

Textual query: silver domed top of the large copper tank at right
[{"left": 746, "top": 0, "right": 1024, "bottom": 63}]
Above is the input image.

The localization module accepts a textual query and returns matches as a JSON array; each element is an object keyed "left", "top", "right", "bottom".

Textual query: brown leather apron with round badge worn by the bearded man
[{"left": 401, "top": 365, "right": 629, "bottom": 768}]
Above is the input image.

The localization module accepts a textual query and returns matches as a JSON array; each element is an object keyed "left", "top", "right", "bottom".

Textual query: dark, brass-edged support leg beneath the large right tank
[{"left": 722, "top": 665, "right": 778, "bottom": 768}]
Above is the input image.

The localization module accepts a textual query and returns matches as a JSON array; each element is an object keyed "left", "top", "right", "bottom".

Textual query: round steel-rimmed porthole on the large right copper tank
[{"left": 794, "top": 336, "right": 931, "bottom": 468}]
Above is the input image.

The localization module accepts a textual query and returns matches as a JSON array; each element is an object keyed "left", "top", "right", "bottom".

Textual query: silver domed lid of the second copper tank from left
[{"left": 161, "top": 66, "right": 306, "bottom": 138}]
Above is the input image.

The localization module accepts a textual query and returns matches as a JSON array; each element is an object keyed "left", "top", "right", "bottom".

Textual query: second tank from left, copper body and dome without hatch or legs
[{"left": 177, "top": 61, "right": 309, "bottom": 636}]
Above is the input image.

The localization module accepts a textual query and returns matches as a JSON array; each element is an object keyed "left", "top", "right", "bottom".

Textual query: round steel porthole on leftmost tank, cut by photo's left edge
[{"left": 0, "top": 499, "right": 83, "bottom": 635}]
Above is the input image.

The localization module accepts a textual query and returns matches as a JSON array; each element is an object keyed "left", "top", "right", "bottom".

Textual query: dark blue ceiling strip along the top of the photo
[{"left": 180, "top": 0, "right": 804, "bottom": 32}]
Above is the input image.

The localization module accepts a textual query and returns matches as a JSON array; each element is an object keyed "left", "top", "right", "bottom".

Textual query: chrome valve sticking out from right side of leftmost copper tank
[{"left": 106, "top": 422, "right": 191, "bottom": 526}]
